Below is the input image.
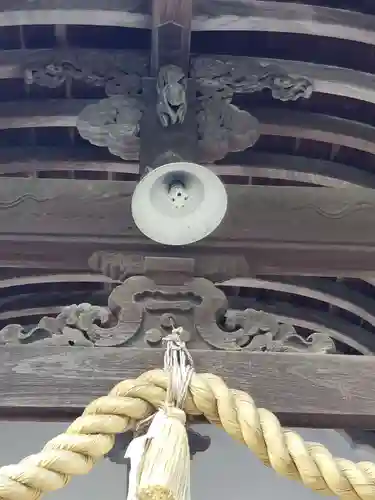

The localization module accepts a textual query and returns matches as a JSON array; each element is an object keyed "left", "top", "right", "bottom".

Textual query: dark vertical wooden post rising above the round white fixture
[{"left": 139, "top": 0, "right": 198, "bottom": 175}]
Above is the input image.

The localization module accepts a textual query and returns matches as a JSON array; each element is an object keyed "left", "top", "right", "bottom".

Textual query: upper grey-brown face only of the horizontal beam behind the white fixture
[{"left": 0, "top": 178, "right": 375, "bottom": 244}]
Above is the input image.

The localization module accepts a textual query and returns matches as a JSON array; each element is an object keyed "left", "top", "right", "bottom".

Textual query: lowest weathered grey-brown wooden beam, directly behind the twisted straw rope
[{"left": 0, "top": 346, "right": 375, "bottom": 428}]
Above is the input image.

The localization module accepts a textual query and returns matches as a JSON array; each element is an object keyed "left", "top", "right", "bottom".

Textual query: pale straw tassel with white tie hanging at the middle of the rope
[{"left": 125, "top": 328, "right": 194, "bottom": 500}]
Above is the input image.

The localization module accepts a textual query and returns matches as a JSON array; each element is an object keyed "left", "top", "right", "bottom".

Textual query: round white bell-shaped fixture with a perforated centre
[{"left": 132, "top": 162, "right": 228, "bottom": 246}]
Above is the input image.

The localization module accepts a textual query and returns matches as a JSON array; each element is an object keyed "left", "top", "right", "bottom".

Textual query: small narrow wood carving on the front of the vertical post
[{"left": 156, "top": 65, "right": 187, "bottom": 127}]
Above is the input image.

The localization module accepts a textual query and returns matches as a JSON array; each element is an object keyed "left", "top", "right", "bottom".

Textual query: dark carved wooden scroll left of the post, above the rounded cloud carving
[{"left": 23, "top": 50, "right": 148, "bottom": 96}]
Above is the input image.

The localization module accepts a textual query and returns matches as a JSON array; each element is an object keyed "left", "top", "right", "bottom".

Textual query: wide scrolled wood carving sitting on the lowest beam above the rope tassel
[{"left": 0, "top": 276, "right": 335, "bottom": 353}]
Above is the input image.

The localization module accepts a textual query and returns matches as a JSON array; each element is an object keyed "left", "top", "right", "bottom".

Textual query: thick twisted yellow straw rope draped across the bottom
[{"left": 0, "top": 370, "right": 375, "bottom": 500}]
